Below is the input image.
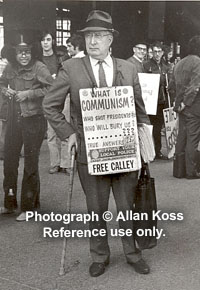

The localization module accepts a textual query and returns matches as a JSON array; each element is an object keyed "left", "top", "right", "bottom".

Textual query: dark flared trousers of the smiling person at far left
[{"left": 3, "top": 112, "right": 46, "bottom": 211}]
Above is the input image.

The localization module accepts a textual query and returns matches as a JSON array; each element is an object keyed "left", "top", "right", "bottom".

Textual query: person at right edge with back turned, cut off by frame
[{"left": 169, "top": 35, "right": 200, "bottom": 179}]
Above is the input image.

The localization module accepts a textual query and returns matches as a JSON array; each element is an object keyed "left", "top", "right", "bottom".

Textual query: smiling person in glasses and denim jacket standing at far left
[{"left": 0, "top": 34, "right": 53, "bottom": 221}]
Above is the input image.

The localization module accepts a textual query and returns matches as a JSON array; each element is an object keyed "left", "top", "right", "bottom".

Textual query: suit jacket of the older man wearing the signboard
[{"left": 43, "top": 56, "right": 150, "bottom": 163}]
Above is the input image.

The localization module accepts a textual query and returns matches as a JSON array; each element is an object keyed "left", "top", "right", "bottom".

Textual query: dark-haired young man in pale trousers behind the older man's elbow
[{"left": 41, "top": 31, "right": 69, "bottom": 175}]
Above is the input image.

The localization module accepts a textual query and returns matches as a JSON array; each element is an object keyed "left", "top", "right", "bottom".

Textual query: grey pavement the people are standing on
[{"left": 0, "top": 141, "right": 200, "bottom": 290}]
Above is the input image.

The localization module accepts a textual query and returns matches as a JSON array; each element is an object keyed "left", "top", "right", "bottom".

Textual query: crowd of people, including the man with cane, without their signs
[{"left": 0, "top": 10, "right": 200, "bottom": 277}]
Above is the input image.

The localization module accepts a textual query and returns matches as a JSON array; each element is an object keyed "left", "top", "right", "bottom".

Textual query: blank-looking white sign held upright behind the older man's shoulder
[{"left": 138, "top": 73, "right": 160, "bottom": 115}]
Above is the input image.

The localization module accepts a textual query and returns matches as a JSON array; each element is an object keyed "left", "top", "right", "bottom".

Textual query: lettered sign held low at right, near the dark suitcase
[{"left": 163, "top": 107, "right": 178, "bottom": 158}]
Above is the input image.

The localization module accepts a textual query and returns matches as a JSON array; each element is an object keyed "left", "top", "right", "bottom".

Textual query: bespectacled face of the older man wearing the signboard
[{"left": 85, "top": 30, "right": 113, "bottom": 60}]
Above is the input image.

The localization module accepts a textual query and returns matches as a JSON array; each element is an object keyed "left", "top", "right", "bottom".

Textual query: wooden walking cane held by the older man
[{"left": 59, "top": 146, "right": 76, "bottom": 276}]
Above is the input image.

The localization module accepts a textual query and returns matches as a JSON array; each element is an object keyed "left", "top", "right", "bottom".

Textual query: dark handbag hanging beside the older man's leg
[{"left": 134, "top": 163, "right": 157, "bottom": 250}]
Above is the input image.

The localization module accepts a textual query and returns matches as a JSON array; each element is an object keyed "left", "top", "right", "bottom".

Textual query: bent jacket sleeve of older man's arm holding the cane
[{"left": 43, "top": 68, "right": 75, "bottom": 141}]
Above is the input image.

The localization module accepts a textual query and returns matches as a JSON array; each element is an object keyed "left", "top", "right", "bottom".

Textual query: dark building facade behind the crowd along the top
[{"left": 0, "top": 0, "right": 200, "bottom": 58}]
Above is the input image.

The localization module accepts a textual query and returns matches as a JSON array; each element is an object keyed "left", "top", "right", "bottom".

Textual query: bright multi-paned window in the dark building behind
[{"left": 56, "top": 8, "right": 71, "bottom": 45}]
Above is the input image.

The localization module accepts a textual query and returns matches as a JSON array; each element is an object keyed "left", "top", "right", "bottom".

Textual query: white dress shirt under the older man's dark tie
[{"left": 89, "top": 54, "right": 113, "bottom": 87}]
